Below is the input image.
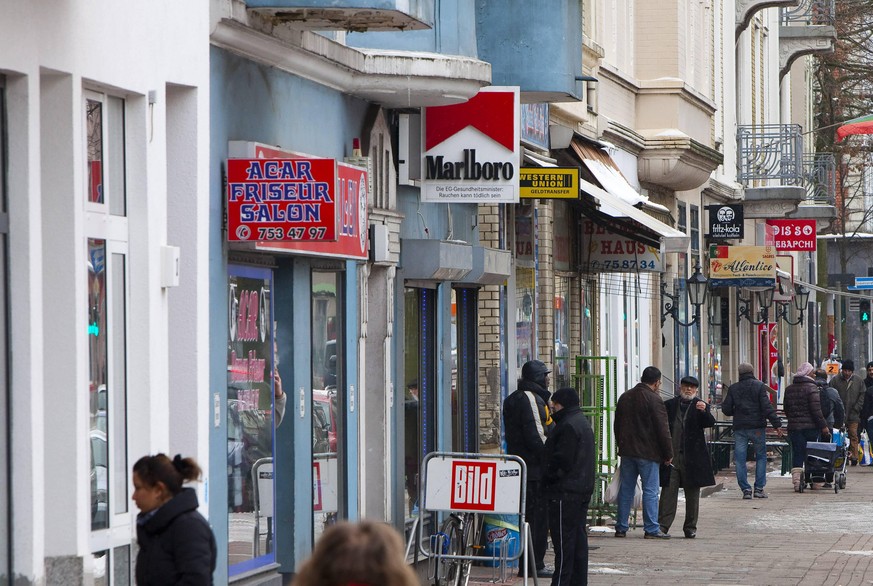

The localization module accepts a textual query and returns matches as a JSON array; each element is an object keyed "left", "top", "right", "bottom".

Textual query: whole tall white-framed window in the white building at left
[{"left": 82, "top": 90, "right": 131, "bottom": 585}]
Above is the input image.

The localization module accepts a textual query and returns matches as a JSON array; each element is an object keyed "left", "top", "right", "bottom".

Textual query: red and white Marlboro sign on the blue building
[{"left": 421, "top": 87, "right": 520, "bottom": 203}]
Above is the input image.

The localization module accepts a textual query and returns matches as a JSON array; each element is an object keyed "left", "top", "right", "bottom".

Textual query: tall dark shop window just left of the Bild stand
[{"left": 403, "top": 288, "right": 437, "bottom": 522}]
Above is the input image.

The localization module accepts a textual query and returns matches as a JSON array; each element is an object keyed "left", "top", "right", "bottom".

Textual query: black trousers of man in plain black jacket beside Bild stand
[{"left": 549, "top": 497, "right": 588, "bottom": 586}]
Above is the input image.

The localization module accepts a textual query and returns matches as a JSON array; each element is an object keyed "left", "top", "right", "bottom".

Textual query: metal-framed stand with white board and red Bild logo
[{"left": 406, "top": 452, "right": 538, "bottom": 585}]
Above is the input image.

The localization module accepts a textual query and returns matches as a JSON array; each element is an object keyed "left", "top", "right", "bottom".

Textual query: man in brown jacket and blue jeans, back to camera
[{"left": 613, "top": 366, "right": 673, "bottom": 539}]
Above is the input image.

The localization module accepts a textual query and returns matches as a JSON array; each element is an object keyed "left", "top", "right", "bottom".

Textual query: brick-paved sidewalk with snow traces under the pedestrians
[{"left": 470, "top": 463, "right": 873, "bottom": 586}]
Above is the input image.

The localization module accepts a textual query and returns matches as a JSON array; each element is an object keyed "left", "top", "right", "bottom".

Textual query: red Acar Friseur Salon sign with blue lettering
[{"left": 227, "top": 159, "right": 337, "bottom": 242}]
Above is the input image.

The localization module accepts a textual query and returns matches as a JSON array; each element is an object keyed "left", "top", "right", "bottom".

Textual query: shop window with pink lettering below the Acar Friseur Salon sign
[{"left": 227, "top": 265, "right": 276, "bottom": 576}]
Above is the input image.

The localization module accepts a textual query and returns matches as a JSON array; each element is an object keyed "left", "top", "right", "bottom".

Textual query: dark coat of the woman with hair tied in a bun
[{"left": 136, "top": 488, "right": 216, "bottom": 586}]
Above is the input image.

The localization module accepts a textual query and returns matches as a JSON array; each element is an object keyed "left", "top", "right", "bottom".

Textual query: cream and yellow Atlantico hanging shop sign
[{"left": 709, "top": 245, "right": 776, "bottom": 287}]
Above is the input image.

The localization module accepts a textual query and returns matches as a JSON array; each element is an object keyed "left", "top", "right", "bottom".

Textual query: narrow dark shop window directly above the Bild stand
[{"left": 451, "top": 288, "right": 479, "bottom": 452}]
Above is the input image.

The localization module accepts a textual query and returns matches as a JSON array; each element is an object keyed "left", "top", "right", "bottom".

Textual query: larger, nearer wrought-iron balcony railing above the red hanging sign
[{"left": 737, "top": 124, "right": 804, "bottom": 187}]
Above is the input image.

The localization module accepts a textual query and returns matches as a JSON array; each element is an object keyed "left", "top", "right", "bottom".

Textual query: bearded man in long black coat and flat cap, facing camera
[{"left": 658, "top": 376, "right": 715, "bottom": 539}]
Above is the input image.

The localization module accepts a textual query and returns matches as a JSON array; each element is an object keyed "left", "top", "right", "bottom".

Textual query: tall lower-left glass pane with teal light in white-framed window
[{"left": 88, "top": 238, "right": 108, "bottom": 530}]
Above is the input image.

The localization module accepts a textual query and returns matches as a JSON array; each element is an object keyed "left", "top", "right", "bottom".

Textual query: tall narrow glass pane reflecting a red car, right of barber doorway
[{"left": 311, "top": 270, "right": 347, "bottom": 541}]
